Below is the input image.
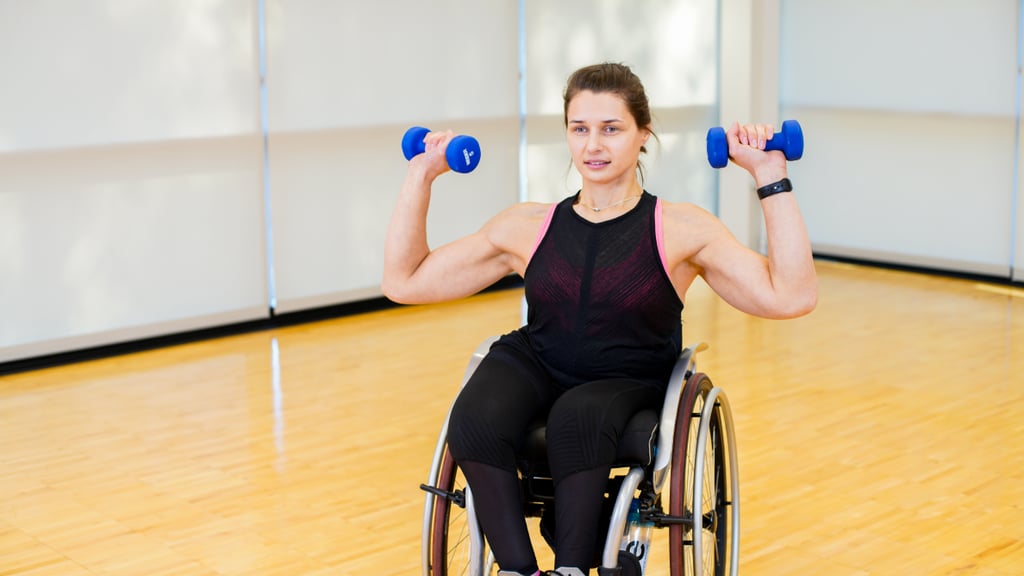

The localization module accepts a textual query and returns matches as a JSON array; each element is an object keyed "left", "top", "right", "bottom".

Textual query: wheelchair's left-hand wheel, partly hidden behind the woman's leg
[{"left": 425, "top": 445, "right": 494, "bottom": 576}]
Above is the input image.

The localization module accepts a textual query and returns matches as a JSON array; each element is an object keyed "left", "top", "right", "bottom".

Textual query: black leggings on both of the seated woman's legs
[{"left": 447, "top": 342, "right": 665, "bottom": 574}]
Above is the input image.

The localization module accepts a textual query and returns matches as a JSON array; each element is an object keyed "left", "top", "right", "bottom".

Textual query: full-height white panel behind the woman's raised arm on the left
[{"left": 267, "top": 0, "right": 519, "bottom": 313}]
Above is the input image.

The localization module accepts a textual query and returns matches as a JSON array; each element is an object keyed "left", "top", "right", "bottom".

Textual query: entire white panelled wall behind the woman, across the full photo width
[{"left": 0, "top": 0, "right": 1024, "bottom": 362}]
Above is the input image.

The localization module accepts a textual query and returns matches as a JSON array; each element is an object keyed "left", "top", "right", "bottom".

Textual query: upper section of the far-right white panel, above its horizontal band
[{"left": 780, "top": 0, "right": 1018, "bottom": 117}]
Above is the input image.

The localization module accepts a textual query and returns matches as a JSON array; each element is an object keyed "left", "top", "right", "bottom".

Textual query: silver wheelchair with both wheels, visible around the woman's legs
[{"left": 421, "top": 337, "right": 739, "bottom": 576}]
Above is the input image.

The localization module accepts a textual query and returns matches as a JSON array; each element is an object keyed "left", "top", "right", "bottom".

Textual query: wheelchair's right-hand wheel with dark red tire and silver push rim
[{"left": 669, "top": 373, "right": 739, "bottom": 576}]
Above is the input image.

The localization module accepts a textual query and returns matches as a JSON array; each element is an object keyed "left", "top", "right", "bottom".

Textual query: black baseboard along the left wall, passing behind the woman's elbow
[{"left": 0, "top": 276, "right": 522, "bottom": 376}]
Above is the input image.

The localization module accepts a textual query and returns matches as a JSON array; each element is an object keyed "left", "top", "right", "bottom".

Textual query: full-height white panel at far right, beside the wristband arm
[{"left": 779, "top": 0, "right": 1020, "bottom": 278}]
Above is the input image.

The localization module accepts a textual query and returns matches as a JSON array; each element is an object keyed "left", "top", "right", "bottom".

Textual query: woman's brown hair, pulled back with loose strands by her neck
[{"left": 562, "top": 63, "right": 657, "bottom": 180}]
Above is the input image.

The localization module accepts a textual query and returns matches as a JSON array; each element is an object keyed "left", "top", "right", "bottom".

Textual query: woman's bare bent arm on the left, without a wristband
[{"left": 381, "top": 128, "right": 513, "bottom": 303}]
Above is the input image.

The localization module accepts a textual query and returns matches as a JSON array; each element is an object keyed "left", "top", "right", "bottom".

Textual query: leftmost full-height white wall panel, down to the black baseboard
[{"left": 0, "top": 0, "right": 267, "bottom": 362}]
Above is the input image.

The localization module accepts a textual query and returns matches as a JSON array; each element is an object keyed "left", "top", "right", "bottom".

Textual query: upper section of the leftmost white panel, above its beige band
[{"left": 0, "top": 0, "right": 259, "bottom": 153}]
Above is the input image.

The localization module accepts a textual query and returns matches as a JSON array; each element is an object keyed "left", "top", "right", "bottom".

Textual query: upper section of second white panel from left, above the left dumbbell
[{"left": 267, "top": 0, "right": 518, "bottom": 130}]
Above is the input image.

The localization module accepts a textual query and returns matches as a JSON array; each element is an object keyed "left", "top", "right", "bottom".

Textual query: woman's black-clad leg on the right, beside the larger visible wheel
[{"left": 548, "top": 379, "right": 665, "bottom": 574}]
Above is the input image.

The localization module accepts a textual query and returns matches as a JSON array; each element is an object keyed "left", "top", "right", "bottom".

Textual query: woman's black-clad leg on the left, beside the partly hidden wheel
[{"left": 447, "top": 344, "right": 552, "bottom": 574}]
